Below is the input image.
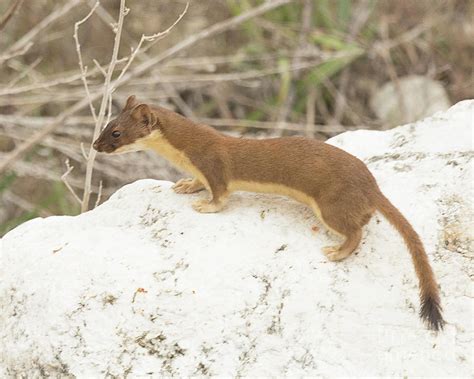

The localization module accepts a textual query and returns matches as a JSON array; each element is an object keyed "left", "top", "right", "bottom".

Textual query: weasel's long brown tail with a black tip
[{"left": 375, "top": 192, "right": 445, "bottom": 330}]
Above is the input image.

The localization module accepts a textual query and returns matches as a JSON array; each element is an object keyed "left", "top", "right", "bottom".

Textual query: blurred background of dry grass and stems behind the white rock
[{"left": 0, "top": 0, "right": 474, "bottom": 236}]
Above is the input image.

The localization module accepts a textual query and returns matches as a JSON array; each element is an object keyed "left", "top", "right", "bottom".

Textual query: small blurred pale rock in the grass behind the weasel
[{"left": 370, "top": 75, "right": 451, "bottom": 126}]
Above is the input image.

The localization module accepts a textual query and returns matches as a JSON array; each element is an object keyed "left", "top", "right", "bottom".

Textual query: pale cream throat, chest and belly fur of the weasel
[{"left": 122, "top": 131, "right": 340, "bottom": 235}]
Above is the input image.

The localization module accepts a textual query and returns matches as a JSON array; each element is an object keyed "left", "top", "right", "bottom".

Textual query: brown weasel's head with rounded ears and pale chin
[{"left": 93, "top": 96, "right": 158, "bottom": 154}]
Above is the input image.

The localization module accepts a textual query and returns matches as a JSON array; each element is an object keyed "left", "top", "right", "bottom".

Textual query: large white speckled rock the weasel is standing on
[{"left": 0, "top": 101, "right": 474, "bottom": 377}]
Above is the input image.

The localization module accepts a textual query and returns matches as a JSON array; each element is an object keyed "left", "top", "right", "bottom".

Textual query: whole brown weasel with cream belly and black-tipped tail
[{"left": 94, "top": 96, "right": 444, "bottom": 330}]
